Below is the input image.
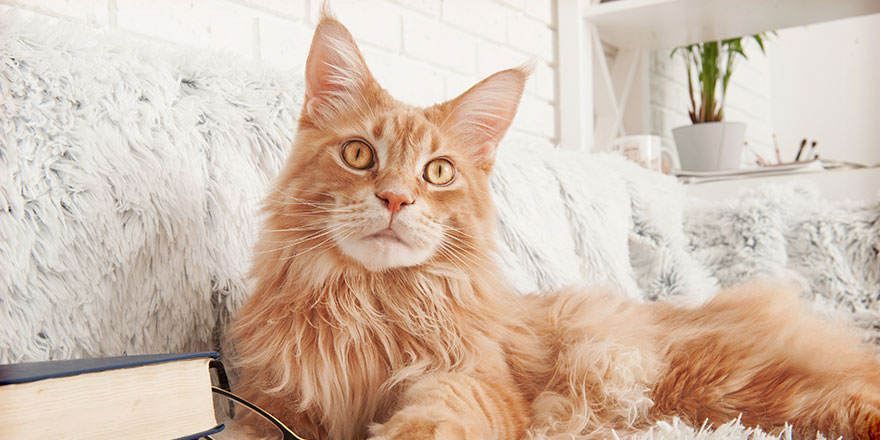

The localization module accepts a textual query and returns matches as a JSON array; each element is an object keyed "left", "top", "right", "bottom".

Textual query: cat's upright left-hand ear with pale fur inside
[{"left": 303, "top": 8, "right": 374, "bottom": 122}]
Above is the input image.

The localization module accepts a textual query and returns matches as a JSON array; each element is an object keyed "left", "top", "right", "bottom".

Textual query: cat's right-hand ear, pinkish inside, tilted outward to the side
[{"left": 438, "top": 67, "right": 531, "bottom": 166}]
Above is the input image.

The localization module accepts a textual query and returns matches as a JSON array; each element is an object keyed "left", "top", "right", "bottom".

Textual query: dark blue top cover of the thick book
[{"left": 0, "top": 351, "right": 220, "bottom": 385}]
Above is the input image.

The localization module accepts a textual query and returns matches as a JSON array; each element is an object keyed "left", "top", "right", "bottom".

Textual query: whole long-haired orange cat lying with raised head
[{"left": 231, "top": 7, "right": 880, "bottom": 440}]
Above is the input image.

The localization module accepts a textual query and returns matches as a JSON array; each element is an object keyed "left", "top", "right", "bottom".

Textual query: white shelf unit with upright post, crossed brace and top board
[{"left": 557, "top": 0, "right": 880, "bottom": 151}]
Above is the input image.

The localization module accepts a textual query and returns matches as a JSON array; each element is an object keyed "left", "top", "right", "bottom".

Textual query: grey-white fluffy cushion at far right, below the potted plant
[{"left": 685, "top": 183, "right": 880, "bottom": 342}]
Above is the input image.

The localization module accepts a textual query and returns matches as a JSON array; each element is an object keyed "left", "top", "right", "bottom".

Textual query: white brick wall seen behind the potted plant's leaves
[{"left": 650, "top": 45, "right": 776, "bottom": 166}]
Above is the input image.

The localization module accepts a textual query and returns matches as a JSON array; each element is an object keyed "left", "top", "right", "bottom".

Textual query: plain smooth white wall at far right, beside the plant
[{"left": 770, "top": 14, "right": 880, "bottom": 164}]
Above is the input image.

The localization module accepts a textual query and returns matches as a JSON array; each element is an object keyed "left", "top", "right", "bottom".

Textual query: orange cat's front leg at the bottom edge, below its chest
[{"left": 370, "top": 373, "right": 529, "bottom": 440}]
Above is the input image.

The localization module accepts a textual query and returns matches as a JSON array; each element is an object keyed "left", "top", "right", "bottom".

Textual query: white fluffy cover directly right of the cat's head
[{"left": 492, "top": 145, "right": 716, "bottom": 303}]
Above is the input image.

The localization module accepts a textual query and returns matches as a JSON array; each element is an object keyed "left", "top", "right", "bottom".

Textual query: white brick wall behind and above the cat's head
[{"left": 0, "top": 0, "right": 558, "bottom": 146}]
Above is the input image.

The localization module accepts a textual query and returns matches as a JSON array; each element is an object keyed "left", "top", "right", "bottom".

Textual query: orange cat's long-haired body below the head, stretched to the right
[{"left": 232, "top": 262, "right": 880, "bottom": 439}]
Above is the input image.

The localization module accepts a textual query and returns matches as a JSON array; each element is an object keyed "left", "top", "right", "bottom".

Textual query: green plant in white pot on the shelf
[{"left": 672, "top": 34, "right": 764, "bottom": 171}]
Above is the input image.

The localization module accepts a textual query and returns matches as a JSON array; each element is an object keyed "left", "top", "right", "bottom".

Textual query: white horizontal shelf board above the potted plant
[{"left": 582, "top": 0, "right": 880, "bottom": 49}]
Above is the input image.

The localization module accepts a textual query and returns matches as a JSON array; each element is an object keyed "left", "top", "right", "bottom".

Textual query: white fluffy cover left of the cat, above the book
[{"left": 0, "top": 16, "right": 301, "bottom": 362}]
